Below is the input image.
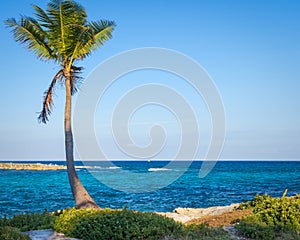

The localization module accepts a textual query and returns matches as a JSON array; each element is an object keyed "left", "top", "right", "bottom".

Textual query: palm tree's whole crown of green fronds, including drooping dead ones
[{"left": 6, "top": 0, "right": 116, "bottom": 123}]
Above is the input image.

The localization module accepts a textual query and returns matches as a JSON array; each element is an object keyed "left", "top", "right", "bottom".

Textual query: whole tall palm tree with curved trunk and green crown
[{"left": 5, "top": 0, "right": 115, "bottom": 208}]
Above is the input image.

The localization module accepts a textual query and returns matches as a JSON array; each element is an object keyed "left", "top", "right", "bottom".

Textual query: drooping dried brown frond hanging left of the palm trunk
[{"left": 38, "top": 70, "right": 63, "bottom": 124}]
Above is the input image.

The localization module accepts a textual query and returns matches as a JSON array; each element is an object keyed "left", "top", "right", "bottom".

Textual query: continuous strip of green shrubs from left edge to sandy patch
[{"left": 0, "top": 208, "right": 231, "bottom": 240}]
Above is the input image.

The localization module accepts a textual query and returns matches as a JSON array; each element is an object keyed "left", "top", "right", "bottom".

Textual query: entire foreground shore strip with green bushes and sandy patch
[{"left": 0, "top": 191, "right": 300, "bottom": 240}]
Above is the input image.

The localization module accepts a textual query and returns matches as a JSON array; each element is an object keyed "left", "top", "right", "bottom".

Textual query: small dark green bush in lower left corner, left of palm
[{"left": 0, "top": 210, "right": 56, "bottom": 232}]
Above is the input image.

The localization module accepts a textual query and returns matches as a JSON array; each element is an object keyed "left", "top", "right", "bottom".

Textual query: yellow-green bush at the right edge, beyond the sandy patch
[{"left": 236, "top": 191, "right": 300, "bottom": 239}]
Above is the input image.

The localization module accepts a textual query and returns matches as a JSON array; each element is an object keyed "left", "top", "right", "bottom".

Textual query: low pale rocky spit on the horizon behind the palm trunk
[{"left": 0, "top": 163, "right": 92, "bottom": 171}]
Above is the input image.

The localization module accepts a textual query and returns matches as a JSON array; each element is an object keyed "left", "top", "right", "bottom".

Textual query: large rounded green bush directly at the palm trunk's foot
[{"left": 54, "top": 208, "right": 229, "bottom": 240}]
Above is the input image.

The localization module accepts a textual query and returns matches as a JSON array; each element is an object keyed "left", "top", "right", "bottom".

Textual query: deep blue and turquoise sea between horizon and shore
[{"left": 0, "top": 161, "right": 300, "bottom": 216}]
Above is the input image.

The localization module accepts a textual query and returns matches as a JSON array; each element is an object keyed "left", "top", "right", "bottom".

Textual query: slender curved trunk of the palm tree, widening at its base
[{"left": 64, "top": 74, "right": 99, "bottom": 209}]
